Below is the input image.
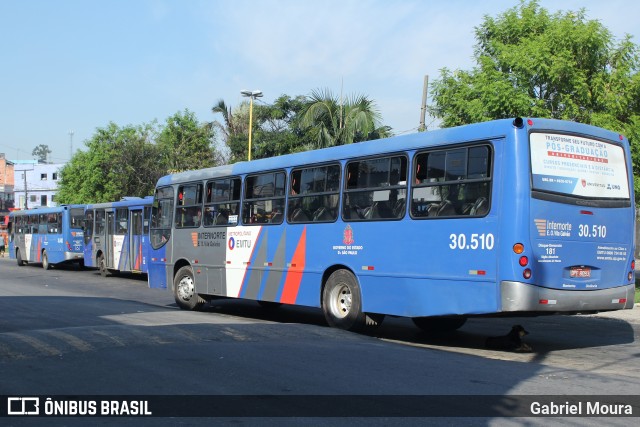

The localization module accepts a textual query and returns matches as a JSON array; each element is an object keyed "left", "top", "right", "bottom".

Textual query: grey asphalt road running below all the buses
[{"left": 0, "top": 258, "right": 640, "bottom": 425}]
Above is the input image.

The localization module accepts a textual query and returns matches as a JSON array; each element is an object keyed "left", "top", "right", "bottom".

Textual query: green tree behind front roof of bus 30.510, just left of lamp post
[{"left": 157, "top": 110, "right": 222, "bottom": 171}]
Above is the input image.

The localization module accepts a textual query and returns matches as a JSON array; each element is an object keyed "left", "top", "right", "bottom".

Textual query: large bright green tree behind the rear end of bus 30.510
[{"left": 430, "top": 0, "right": 640, "bottom": 196}]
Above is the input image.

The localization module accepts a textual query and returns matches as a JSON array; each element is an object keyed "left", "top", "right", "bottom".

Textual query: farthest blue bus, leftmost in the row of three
[{"left": 9, "top": 205, "right": 84, "bottom": 270}]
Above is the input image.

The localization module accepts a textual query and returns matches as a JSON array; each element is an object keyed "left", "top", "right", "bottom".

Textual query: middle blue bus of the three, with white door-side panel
[{"left": 84, "top": 196, "right": 153, "bottom": 276}]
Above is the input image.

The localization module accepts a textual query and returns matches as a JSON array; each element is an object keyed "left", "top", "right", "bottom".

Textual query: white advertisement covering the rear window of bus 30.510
[{"left": 530, "top": 133, "right": 629, "bottom": 199}]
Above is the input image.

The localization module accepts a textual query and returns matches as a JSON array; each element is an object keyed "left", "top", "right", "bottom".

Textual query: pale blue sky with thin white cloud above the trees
[{"left": 0, "top": 0, "right": 640, "bottom": 163}]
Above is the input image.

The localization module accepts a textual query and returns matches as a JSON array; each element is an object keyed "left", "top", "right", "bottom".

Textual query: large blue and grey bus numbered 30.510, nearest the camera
[{"left": 148, "top": 118, "right": 635, "bottom": 330}]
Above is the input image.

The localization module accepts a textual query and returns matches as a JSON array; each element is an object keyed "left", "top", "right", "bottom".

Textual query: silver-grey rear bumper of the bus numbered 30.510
[{"left": 500, "top": 281, "right": 635, "bottom": 313}]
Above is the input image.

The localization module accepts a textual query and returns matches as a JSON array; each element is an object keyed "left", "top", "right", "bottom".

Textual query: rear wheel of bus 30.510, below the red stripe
[{"left": 322, "top": 270, "right": 366, "bottom": 331}]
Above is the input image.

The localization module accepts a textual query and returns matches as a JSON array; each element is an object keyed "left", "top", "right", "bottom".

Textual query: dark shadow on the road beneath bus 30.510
[{"left": 198, "top": 299, "right": 635, "bottom": 355}]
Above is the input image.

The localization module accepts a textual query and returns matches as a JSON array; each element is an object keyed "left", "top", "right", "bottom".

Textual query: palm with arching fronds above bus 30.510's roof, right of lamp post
[{"left": 302, "top": 89, "right": 391, "bottom": 148}]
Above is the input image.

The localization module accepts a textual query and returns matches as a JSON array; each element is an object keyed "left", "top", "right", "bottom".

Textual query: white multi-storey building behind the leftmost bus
[{"left": 14, "top": 160, "right": 64, "bottom": 209}]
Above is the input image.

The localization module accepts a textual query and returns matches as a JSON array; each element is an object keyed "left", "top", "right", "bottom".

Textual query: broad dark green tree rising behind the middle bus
[{"left": 56, "top": 123, "right": 166, "bottom": 204}]
